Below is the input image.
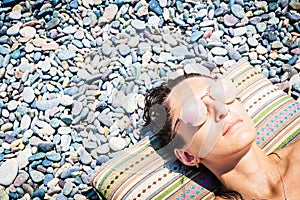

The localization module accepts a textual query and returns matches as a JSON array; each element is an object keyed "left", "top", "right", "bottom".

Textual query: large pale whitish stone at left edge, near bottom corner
[{"left": 0, "top": 158, "right": 18, "bottom": 186}]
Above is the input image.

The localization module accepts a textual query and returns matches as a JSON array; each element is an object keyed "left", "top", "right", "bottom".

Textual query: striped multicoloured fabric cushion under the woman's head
[{"left": 91, "top": 61, "right": 300, "bottom": 200}]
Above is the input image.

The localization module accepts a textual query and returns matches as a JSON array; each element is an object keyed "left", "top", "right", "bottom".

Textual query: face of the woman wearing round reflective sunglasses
[{"left": 167, "top": 77, "right": 256, "bottom": 158}]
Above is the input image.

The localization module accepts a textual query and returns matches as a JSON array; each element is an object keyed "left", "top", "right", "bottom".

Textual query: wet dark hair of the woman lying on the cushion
[{"left": 144, "top": 74, "right": 243, "bottom": 199}]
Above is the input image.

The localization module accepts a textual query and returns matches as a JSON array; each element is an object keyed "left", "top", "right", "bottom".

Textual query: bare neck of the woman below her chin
[{"left": 203, "top": 143, "right": 282, "bottom": 199}]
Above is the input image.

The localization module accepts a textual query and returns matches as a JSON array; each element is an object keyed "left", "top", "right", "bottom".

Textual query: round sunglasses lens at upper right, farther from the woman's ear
[{"left": 210, "top": 79, "right": 237, "bottom": 104}]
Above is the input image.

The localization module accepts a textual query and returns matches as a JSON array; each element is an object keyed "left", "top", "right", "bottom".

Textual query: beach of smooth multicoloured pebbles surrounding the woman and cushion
[{"left": 0, "top": 0, "right": 300, "bottom": 200}]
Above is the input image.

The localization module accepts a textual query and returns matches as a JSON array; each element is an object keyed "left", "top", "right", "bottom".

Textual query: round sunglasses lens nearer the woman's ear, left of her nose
[{"left": 180, "top": 98, "right": 207, "bottom": 126}]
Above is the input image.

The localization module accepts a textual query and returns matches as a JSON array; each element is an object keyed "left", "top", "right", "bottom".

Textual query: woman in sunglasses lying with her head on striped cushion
[{"left": 144, "top": 74, "right": 300, "bottom": 199}]
